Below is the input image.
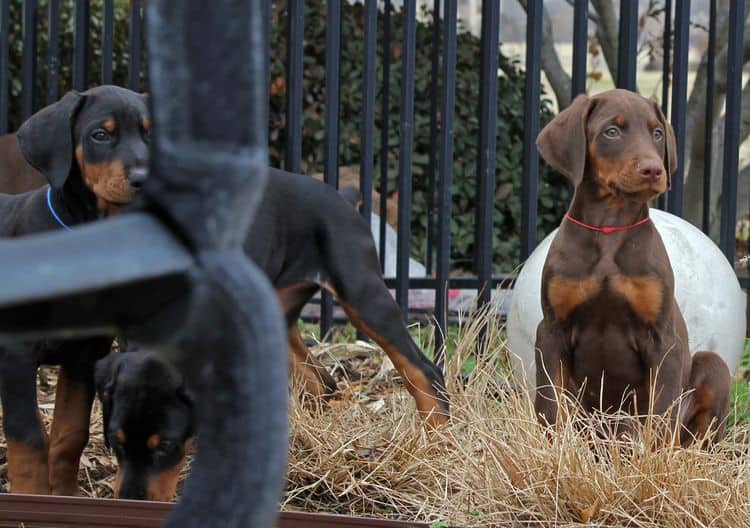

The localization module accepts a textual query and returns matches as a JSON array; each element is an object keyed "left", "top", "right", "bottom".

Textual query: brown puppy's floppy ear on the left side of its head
[{"left": 536, "top": 94, "right": 593, "bottom": 185}]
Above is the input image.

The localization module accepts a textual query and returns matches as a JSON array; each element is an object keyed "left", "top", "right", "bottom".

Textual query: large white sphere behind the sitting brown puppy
[{"left": 506, "top": 209, "right": 747, "bottom": 390}]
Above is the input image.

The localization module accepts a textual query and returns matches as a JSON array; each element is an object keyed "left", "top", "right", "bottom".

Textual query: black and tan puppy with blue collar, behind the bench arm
[{"left": 0, "top": 86, "right": 149, "bottom": 495}]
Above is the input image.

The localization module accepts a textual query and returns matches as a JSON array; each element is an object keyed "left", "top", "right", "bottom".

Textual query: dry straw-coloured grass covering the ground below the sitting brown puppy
[{"left": 283, "top": 313, "right": 750, "bottom": 527}]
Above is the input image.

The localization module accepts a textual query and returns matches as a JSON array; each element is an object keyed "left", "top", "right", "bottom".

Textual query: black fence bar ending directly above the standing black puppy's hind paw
[{"left": 435, "top": 0, "right": 457, "bottom": 367}]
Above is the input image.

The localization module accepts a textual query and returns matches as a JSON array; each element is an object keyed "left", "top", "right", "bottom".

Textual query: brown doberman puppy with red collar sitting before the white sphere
[{"left": 535, "top": 90, "right": 730, "bottom": 444}]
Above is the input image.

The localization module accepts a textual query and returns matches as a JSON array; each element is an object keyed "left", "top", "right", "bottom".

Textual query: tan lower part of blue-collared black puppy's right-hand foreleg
[{"left": 49, "top": 369, "right": 93, "bottom": 495}]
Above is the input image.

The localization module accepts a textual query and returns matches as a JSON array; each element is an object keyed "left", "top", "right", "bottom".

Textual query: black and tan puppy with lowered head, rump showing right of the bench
[{"left": 92, "top": 169, "right": 448, "bottom": 500}]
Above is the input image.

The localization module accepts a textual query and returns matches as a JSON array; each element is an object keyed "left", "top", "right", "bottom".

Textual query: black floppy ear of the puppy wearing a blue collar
[{"left": 17, "top": 92, "right": 86, "bottom": 189}]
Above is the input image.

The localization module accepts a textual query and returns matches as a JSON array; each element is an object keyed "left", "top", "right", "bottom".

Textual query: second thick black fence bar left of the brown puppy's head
[{"left": 476, "top": 0, "right": 500, "bottom": 306}]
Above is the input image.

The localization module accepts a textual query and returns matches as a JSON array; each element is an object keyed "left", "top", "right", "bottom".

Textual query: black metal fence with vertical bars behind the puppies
[{"left": 0, "top": 0, "right": 750, "bottom": 344}]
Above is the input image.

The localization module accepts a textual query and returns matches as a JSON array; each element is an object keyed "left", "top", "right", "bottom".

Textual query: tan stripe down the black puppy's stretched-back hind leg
[{"left": 339, "top": 298, "right": 448, "bottom": 426}]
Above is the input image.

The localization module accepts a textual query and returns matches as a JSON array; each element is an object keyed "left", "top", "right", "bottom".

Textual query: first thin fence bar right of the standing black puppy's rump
[{"left": 378, "top": 0, "right": 391, "bottom": 273}]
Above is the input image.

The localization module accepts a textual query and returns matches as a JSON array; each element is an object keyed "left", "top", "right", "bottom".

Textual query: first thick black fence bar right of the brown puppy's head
[{"left": 668, "top": 0, "right": 690, "bottom": 216}]
